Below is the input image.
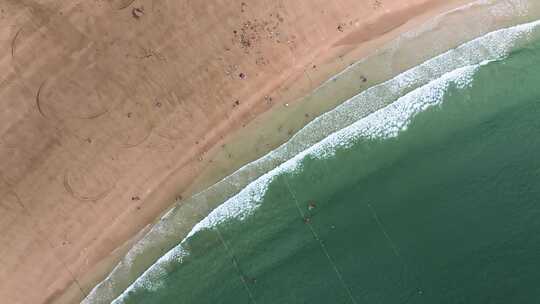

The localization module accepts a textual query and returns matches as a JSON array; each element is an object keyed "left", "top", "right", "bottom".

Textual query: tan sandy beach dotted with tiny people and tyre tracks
[{"left": 0, "top": 0, "right": 470, "bottom": 304}]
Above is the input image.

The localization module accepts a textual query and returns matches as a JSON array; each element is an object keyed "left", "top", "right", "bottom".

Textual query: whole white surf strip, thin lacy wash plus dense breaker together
[{"left": 83, "top": 8, "right": 540, "bottom": 303}]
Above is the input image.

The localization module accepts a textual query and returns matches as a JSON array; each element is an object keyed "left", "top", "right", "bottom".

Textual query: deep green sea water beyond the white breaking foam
[{"left": 116, "top": 29, "right": 540, "bottom": 303}]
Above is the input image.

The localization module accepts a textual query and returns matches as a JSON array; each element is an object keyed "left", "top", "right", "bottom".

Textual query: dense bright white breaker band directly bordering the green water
[{"left": 113, "top": 65, "right": 480, "bottom": 304}]
